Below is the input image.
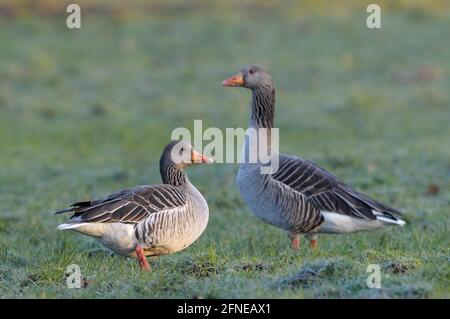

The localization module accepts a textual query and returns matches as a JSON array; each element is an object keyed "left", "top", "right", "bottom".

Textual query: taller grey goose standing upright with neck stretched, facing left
[{"left": 222, "top": 65, "right": 405, "bottom": 249}]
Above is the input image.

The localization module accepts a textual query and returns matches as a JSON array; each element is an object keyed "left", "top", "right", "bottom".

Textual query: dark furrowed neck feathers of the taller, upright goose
[{"left": 250, "top": 85, "right": 275, "bottom": 128}]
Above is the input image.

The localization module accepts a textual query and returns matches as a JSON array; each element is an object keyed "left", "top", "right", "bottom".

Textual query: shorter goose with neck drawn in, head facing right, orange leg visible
[{"left": 55, "top": 141, "right": 213, "bottom": 271}]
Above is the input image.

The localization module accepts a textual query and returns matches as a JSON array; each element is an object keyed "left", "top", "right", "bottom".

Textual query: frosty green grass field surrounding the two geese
[{"left": 0, "top": 1, "right": 450, "bottom": 298}]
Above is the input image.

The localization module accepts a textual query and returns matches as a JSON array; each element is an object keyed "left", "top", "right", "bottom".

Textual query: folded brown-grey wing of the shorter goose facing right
[{"left": 56, "top": 184, "right": 186, "bottom": 224}]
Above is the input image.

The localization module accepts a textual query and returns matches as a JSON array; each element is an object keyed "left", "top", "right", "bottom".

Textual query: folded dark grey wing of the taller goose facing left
[{"left": 272, "top": 155, "right": 400, "bottom": 221}]
